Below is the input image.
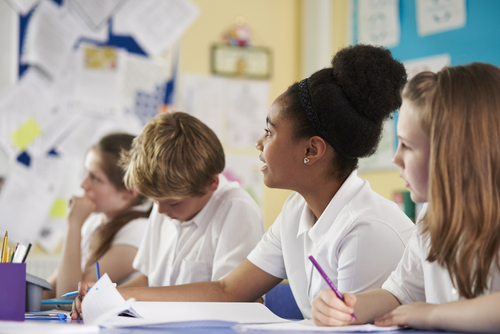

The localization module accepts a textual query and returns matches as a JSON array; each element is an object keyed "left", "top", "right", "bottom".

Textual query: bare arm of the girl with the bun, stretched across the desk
[{"left": 72, "top": 260, "right": 282, "bottom": 319}]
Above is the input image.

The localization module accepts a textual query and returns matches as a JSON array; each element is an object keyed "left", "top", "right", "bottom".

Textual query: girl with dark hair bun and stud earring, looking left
[{"left": 73, "top": 45, "right": 414, "bottom": 318}]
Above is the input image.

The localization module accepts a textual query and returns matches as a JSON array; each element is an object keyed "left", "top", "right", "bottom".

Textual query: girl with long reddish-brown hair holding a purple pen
[{"left": 313, "top": 63, "right": 500, "bottom": 333}]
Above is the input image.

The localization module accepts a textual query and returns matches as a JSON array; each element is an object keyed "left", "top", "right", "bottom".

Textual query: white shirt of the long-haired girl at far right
[{"left": 382, "top": 228, "right": 500, "bottom": 304}]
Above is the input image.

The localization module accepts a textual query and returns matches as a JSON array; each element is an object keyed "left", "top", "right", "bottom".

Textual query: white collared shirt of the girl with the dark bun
[{"left": 248, "top": 171, "right": 414, "bottom": 318}]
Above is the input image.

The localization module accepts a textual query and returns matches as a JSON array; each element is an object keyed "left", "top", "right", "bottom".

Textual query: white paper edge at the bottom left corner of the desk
[{"left": 0, "top": 321, "right": 100, "bottom": 334}]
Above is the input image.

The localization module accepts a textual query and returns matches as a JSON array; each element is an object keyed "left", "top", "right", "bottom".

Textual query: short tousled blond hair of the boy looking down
[{"left": 121, "top": 112, "right": 225, "bottom": 199}]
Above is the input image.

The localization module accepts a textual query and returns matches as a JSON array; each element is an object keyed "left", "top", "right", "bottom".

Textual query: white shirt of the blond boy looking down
[{"left": 133, "top": 175, "right": 264, "bottom": 286}]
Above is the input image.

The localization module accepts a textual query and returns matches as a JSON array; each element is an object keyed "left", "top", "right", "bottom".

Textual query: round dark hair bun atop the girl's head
[{"left": 332, "top": 44, "right": 407, "bottom": 122}]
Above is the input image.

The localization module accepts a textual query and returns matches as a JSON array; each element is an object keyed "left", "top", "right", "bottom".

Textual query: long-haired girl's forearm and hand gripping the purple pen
[{"left": 311, "top": 289, "right": 400, "bottom": 326}]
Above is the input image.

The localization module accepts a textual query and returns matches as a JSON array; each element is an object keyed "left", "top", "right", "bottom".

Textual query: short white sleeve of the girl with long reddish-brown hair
[{"left": 382, "top": 230, "right": 425, "bottom": 304}]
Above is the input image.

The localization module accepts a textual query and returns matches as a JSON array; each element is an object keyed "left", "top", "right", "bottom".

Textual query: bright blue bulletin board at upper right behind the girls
[{"left": 350, "top": 0, "right": 500, "bottom": 170}]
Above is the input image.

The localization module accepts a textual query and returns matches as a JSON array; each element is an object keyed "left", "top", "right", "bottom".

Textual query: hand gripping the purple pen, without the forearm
[{"left": 311, "top": 289, "right": 356, "bottom": 326}]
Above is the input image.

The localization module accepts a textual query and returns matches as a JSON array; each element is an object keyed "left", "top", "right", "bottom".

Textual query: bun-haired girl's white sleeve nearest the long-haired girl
[{"left": 337, "top": 221, "right": 405, "bottom": 293}]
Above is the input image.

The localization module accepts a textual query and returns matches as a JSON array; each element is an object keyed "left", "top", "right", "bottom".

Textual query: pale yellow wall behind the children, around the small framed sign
[{"left": 181, "top": 0, "right": 404, "bottom": 228}]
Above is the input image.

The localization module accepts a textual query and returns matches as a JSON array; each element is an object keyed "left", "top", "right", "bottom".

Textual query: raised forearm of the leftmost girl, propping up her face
[{"left": 56, "top": 197, "right": 95, "bottom": 297}]
